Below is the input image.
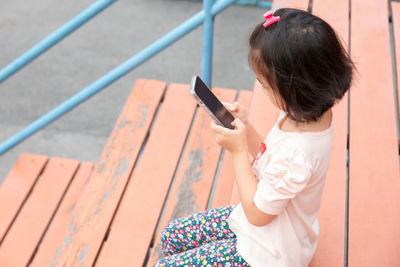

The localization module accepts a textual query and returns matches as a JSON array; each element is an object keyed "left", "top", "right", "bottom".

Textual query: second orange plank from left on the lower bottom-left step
[{"left": 0, "top": 158, "right": 79, "bottom": 266}]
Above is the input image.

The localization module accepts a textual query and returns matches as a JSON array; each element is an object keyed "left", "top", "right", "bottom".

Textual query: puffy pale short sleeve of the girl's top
[{"left": 254, "top": 150, "right": 312, "bottom": 215}]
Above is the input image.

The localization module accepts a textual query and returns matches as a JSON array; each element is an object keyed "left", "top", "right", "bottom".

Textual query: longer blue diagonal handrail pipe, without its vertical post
[{"left": 0, "top": 0, "right": 235, "bottom": 155}]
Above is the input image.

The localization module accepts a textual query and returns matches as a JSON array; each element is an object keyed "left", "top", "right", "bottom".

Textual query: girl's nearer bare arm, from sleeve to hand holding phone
[{"left": 211, "top": 119, "right": 276, "bottom": 226}]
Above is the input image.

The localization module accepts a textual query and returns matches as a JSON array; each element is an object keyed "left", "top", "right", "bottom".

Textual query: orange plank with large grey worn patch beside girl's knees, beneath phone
[{"left": 147, "top": 89, "right": 236, "bottom": 266}]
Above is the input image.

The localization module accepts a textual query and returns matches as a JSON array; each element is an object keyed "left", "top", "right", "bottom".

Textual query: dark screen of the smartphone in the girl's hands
[{"left": 194, "top": 77, "right": 235, "bottom": 129}]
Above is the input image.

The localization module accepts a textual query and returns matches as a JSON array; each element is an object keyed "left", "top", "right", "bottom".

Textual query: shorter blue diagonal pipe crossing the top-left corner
[{"left": 0, "top": 0, "right": 116, "bottom": 83}]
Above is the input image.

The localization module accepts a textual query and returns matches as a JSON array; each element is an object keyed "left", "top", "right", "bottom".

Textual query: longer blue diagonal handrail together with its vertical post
[{"left": 0, "top": 0, "right": 250, "bottom": 155}]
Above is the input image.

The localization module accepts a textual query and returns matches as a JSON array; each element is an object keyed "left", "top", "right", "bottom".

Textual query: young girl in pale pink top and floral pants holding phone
[{"left": 152, "top": 8, "right": 354, "bottom": 267}]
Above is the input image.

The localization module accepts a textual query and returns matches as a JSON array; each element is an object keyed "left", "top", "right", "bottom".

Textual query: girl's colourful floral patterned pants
[{"left": 154, "top": 206, "right": 250, "bottom": 267}]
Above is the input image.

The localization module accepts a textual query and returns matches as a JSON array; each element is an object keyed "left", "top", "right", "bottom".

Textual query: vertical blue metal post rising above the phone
[{"left": 201, "top": 0, "right": 214, "bottom": 87}]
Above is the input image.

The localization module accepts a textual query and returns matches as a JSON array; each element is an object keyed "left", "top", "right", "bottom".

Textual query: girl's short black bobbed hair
[{"left": 249, "top": 8, "right": 355, "bottom": 122}]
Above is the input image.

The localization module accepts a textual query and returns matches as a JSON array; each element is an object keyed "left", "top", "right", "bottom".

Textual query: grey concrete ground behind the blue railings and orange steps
[{"left": 0, "top": 0, "right": 264, "bottom": 183}]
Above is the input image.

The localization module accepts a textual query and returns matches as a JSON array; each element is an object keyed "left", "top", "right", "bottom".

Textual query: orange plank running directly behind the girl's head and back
[{"left": 310, "top": 0, "right": 349, "bottom": 267}]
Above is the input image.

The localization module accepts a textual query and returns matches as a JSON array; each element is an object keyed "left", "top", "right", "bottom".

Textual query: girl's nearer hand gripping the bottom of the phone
[{"left": 211, "top": 119, "right": 248, "bottom": 154}]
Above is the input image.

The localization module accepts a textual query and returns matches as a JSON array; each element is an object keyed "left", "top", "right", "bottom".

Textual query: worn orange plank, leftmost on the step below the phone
[{"left": 49, "top": 80, "right": 166, "bottom": 266}]
